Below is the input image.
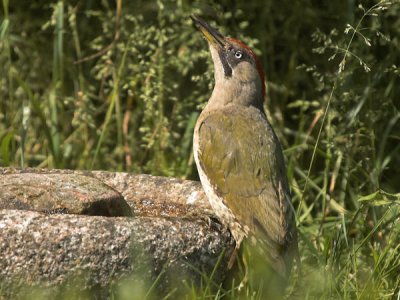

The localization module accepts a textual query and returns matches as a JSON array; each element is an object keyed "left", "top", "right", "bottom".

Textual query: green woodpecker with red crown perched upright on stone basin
[{"left": 192, "top": 16, "right": 297, "bottom": 277}]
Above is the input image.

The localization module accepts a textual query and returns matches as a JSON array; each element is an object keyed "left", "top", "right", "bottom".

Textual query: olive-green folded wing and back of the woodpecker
[{"left": 198, "top": 108, "right": 297, "bottom": 273}]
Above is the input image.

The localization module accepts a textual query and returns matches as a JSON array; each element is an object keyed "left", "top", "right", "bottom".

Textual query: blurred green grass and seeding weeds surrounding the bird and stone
[{"left": 0, "top": 0, "right": 400, "bottom": 299}]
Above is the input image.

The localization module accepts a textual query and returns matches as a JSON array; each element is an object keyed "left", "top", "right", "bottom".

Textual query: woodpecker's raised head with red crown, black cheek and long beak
[{"left": 191, "top": 16, "right": 265, "bottom": 108}]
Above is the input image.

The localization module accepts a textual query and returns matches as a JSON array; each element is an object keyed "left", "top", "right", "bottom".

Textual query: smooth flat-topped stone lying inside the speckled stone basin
[{"left": 0, "top": 173, "right": 132, "bottom": 216}]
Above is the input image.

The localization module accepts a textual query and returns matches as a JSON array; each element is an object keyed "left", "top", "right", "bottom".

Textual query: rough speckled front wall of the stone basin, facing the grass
[{"left": 0, "top": 210, "right": 234, "bottom": 297}]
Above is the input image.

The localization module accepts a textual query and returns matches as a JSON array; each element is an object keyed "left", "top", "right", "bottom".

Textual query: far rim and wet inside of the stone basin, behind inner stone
[{"left": 0, "top": 168, "right": 213, "bottom": 216}]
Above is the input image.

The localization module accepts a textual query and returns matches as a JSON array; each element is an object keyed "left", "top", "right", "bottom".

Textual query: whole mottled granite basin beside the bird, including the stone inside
[{"left": 0, "top": 168, "right": 234, "bottom": 298}]
